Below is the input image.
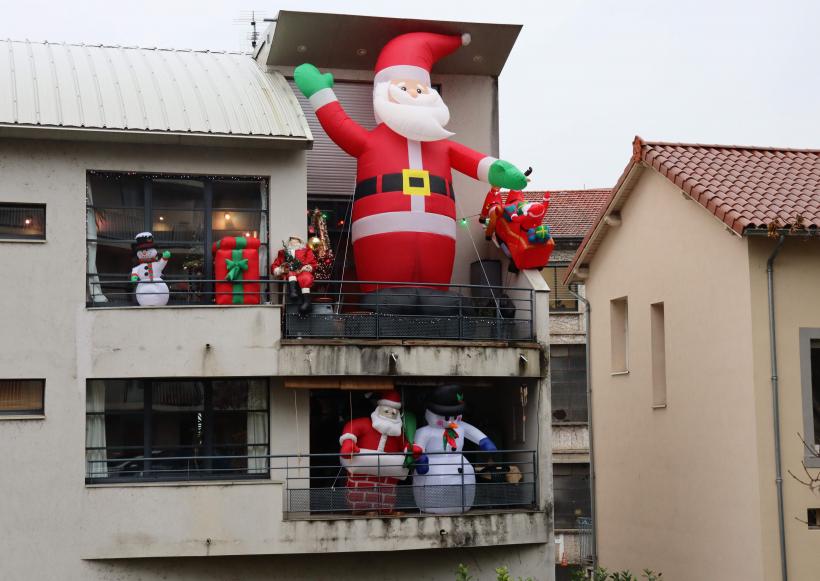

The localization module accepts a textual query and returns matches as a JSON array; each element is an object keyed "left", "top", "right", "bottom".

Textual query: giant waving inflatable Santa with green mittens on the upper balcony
[{"left": 294, "top": 32, "right": 527, "bottom": 290}]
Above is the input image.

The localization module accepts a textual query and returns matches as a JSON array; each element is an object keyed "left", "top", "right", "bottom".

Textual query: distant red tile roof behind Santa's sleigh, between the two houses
[{"left": 524, "top": 188, "right": 612, "bottom": 238}]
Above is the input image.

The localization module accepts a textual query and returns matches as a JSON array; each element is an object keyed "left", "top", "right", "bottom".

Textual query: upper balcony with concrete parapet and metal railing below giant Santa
[{"left": 88, "top": 271, "right": 548, "bottom": 378}]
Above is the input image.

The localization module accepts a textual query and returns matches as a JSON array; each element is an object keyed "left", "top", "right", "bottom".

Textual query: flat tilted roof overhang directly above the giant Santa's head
[{"left": 265, "top": 10, "right": 522, "bottom": 77}]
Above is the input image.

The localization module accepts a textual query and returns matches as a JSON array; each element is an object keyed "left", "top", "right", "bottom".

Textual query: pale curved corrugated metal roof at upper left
[{"left": 0, "top": 40, "right": 312, "bottom": 142}]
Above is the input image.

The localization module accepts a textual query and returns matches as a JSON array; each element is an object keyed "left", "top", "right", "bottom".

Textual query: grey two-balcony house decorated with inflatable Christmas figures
[{"left": 0, "top": 11, "right": 554, "bottom": 580}]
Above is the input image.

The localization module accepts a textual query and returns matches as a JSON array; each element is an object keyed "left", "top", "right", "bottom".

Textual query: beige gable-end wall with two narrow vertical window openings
[{"left": 586, "top": 169, "right": 767, "bottom": 581}]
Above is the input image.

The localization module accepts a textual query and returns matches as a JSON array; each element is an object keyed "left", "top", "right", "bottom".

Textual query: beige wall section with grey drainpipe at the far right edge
[{"left": 749, "top": 238, "right": 820, "bottom": 579}]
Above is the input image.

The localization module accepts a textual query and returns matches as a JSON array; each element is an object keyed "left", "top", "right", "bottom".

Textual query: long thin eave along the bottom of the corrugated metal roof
[{"left": 0, "top": 123, "right": 313, "bottom": 149}]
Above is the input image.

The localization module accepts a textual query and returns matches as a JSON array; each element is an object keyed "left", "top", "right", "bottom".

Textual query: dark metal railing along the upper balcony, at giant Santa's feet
[{"left": 88, "top": 274, "right": 546, "bottom": 341}]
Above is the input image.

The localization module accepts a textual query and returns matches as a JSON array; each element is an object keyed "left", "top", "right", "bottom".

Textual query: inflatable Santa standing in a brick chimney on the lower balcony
[{"left": 339, "top": 390, "right": 427, "bottom": 514}]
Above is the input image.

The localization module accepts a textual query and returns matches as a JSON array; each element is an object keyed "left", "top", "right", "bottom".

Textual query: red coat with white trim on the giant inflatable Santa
[{"left": 316, "top": 100, "right": 494, "bottom": 290}]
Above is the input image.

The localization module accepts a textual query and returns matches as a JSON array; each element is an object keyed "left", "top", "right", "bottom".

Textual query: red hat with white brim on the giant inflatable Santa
[{"left": 373, "top": 32, "right": 470, "bottom": 86}]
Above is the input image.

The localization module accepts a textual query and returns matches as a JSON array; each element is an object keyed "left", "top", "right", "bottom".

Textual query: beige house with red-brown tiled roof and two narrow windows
[{"left": 568, "top": 138, "right": 820, "bottom": 581}]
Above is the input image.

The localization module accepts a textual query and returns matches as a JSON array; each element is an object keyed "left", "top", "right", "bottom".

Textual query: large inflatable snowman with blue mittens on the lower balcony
[{"left": 413, "top": 385, "right": 496, "bottom": 514}]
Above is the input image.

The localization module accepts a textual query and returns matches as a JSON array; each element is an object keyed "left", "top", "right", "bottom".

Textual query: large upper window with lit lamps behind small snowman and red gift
[{"left": 86, "top": 171, "right": 269, "bottom": 305}]
